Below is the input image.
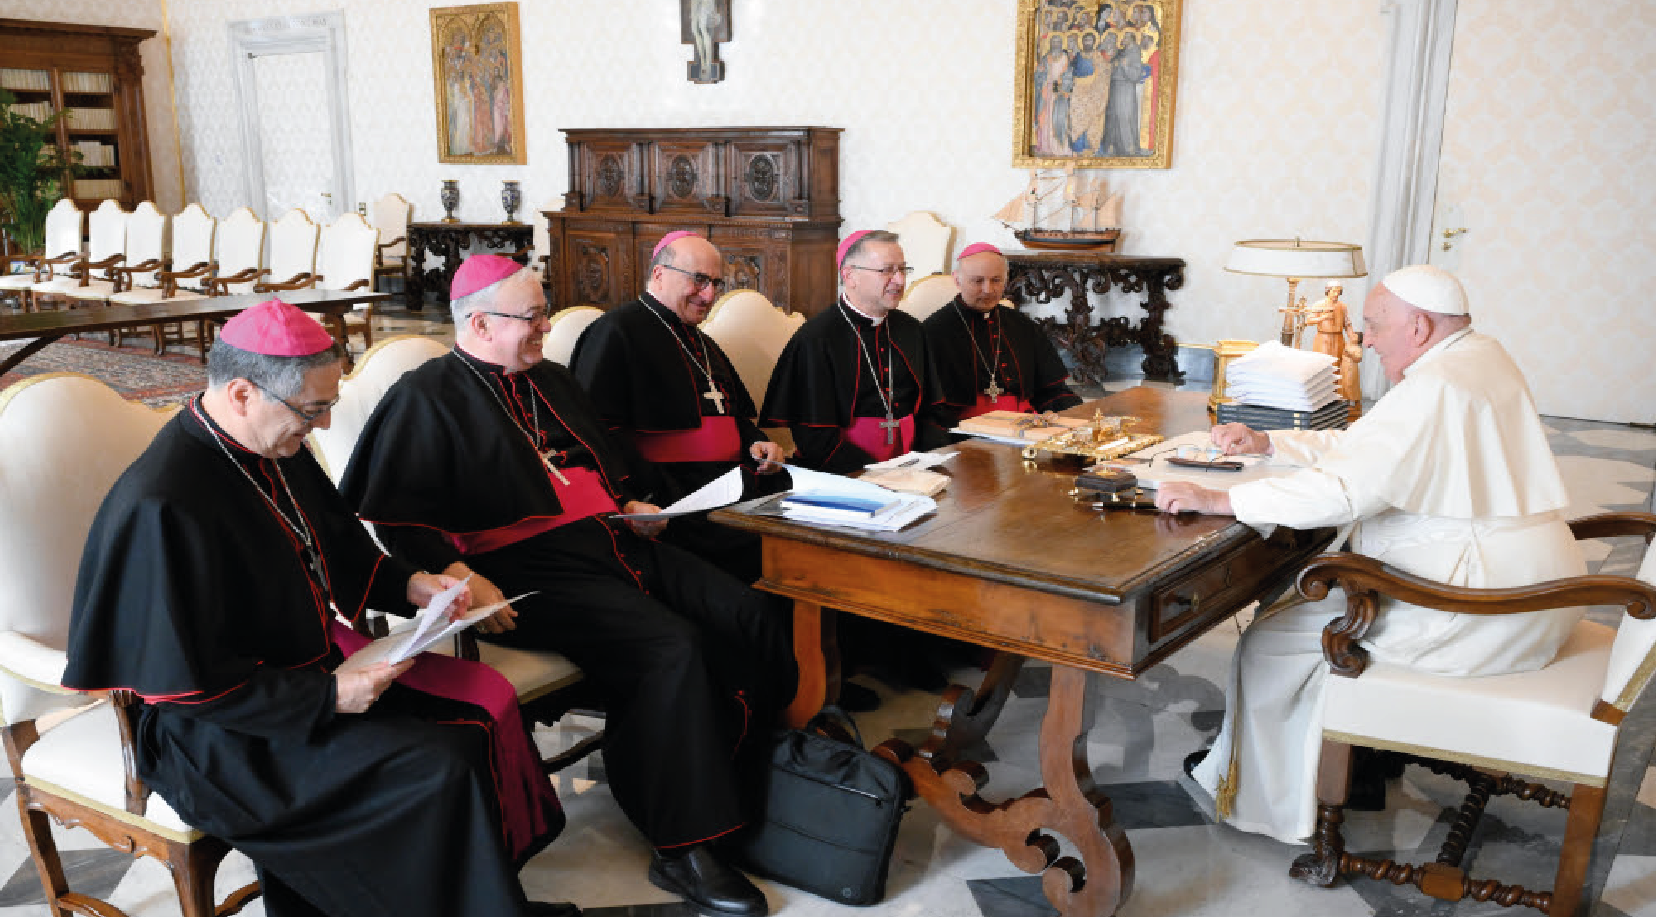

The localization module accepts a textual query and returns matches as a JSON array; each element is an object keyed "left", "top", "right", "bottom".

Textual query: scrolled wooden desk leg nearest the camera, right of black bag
[{"left": 877, "top": 665, "right": 1133, "bottom": 917}]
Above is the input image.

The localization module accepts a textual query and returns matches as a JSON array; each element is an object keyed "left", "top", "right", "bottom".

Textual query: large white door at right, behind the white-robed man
[{"left": 1432, "top": 0, "right": 1657, "bottom": 423}]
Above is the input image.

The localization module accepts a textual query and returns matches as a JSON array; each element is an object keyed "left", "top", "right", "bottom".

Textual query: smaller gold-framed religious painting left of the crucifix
[{"left": 431, "top": 3, "right": 529, "bottom": 166}]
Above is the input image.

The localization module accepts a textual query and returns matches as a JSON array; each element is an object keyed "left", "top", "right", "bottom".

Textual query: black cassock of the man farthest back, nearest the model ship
[{"left": 923, "top": 297, "right": 1082, "bottom": 411}]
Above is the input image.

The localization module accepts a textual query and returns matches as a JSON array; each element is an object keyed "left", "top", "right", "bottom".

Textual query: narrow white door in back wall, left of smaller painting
[{"left": 252, "top": 51, "right": 340, "bottom": 224}]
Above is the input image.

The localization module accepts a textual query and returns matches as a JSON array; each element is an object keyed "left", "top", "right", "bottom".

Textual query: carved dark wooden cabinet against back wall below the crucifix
[{"left": 542, "top": 128, "right": 840, "bottom": 315}]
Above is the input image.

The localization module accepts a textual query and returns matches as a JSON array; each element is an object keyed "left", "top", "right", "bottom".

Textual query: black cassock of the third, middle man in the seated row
[{"left": 570, "top": 294, "right": 789, "bottom": 582}]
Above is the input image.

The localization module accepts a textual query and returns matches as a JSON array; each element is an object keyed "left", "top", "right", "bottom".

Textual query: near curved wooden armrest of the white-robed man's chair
[{"left": 1296, "top": 552, "right": 1657, "bottom": 678}]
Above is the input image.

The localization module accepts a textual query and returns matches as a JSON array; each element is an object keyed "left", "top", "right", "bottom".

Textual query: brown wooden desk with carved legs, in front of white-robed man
[{"left": 714, "top": 388, "right": 1331, "bottom": 917}]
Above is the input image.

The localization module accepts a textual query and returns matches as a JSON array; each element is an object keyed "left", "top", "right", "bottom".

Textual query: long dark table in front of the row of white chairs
[{"left": 0, "top": 290, "right": 391, "bottom": 375}]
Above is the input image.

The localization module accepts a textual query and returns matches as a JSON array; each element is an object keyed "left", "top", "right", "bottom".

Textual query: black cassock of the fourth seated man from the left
[{"left": 759, "top": 300, "right": 954, "bottom": 474}]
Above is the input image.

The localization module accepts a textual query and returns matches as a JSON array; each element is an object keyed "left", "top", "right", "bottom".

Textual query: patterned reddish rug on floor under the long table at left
[{"left": 0, "top": 337, "right": 207, "bottom": 406}]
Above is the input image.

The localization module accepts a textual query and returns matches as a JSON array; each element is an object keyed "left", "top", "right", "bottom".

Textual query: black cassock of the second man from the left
[{"left": 340, "top": 350, "right": 794, "bottom": 847}]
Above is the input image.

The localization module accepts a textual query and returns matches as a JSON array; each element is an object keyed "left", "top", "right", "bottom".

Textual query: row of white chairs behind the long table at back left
[{"left": 0, "top": 199, "right": 381, "bottom": 353}]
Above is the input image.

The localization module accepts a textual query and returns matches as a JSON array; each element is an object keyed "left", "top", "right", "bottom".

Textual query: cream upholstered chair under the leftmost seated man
[{"left": 0, "top": 373, "right": 258, "bottom": 917}]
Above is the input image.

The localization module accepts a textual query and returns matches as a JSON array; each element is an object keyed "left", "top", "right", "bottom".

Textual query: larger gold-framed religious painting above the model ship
[{"left": 1012, "top": 0, "right": 1183, "bottom": 169}]
